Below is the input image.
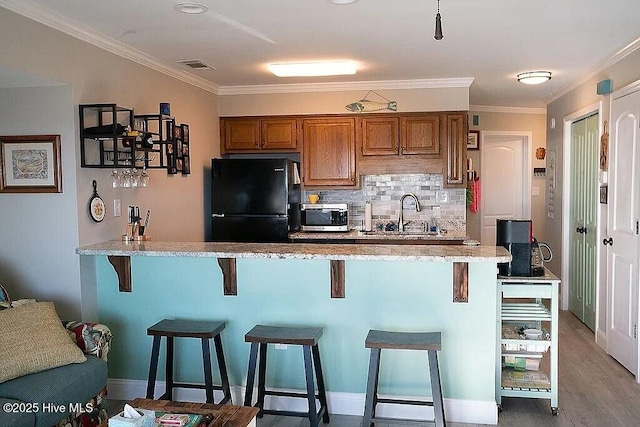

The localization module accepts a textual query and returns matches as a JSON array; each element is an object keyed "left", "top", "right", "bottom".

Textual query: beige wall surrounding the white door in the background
[{"left": 467, "top": 110, "right": 546, "bottom": 241}]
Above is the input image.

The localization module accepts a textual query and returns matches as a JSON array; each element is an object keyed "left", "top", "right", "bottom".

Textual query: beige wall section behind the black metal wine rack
[{"left": 0, "top": 8, "right": 219, "bottom": 244}]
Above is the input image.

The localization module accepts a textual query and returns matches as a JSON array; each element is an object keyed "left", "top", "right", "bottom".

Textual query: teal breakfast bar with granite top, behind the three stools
[{"left": 76, "top": 241, "right": 511, "bottom": 424}]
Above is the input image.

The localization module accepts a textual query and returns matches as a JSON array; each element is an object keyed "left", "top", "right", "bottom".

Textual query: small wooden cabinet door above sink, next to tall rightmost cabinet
[{"left": 400, "top": 114, "right": 440, "bottom": 155}]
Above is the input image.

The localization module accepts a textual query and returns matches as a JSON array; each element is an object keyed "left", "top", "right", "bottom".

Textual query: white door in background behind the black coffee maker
[{"left": 480, "top": 132, "right": 531, "bottom": 246}]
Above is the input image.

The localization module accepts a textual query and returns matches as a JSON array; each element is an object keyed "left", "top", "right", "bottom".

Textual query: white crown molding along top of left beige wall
[{"left": 0, "top": 0, "right": 220, "bottom": 94}]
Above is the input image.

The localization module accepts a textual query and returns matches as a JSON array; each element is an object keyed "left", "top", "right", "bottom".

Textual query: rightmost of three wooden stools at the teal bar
[{"left": 362, "top": 329, "right": 446, "bottom": 427}]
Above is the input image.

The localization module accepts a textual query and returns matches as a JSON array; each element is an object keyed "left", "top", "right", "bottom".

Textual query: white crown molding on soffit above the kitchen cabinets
[{"left": 219, "top": 77, "right": 473, "bottom": 95}]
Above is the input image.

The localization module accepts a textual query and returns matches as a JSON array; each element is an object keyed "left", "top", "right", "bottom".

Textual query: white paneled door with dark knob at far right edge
[{"left": 607, "top": 92, "right": 640, "bottom": 378}]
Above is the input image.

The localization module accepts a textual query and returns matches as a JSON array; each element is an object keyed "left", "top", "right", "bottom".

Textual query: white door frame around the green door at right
[{"left": 560, "top": 101, "right": 603, "bottom": 322}]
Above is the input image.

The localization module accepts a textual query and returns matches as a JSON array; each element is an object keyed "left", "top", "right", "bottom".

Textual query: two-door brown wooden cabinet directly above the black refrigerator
[{"left": 220, "top": 117, "right": 298, "bottom": 154}]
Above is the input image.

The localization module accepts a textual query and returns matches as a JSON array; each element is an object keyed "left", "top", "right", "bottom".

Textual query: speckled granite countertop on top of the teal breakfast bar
[{"left": 76, "top": 240, "right": 511, "bottom": 263}]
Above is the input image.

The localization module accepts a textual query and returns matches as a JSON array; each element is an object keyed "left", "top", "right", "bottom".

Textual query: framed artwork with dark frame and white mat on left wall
[{"left": 0, "top": 135, "right": 62, "bottom": 193}]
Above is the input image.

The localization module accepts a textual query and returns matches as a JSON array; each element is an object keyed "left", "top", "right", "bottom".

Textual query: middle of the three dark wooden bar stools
[{"left": 244, "top": 325, "right": 329, "bottom": 427}]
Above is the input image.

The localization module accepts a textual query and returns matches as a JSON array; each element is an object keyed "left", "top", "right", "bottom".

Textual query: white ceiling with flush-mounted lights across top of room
[{"left": 0, "top": 0, "right": 640, "bottom": 108}]
